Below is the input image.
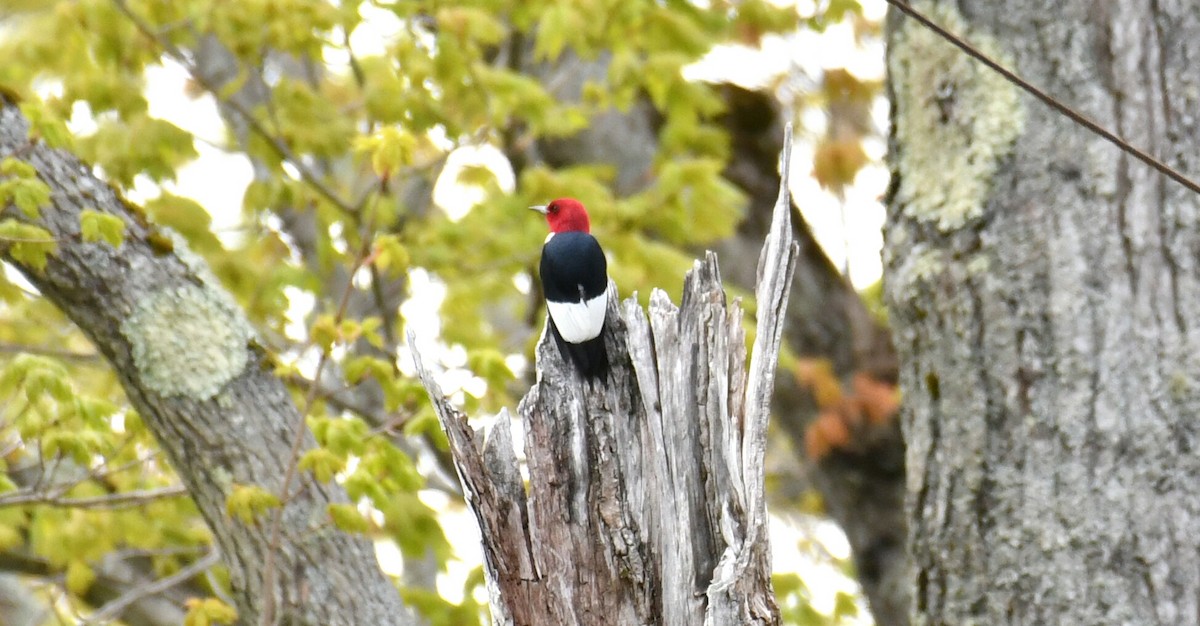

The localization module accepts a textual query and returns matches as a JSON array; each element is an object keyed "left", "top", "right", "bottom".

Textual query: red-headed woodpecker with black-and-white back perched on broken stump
[{"left": 530, "top": 198, "right": 608, "bottom": 380}]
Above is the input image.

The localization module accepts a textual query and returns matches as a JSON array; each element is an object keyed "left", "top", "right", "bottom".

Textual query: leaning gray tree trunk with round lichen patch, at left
[{"left": 0, "top": 102, "right": 415, "bottom": 625}]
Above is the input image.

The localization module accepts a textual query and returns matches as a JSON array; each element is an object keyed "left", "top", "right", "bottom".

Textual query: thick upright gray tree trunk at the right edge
[{"left": 886, "top": 0, "right": 1200, "bottom": 625}]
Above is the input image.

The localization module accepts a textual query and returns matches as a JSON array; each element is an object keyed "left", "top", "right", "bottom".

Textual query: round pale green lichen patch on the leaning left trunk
[{"left": 121, "top": 284, "right": 252, "bottom": 401}]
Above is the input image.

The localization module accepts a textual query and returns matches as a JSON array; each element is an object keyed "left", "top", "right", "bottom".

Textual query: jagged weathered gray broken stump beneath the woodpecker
[{"left": 410, "top": 131, "right": 797, "bottom": 626}]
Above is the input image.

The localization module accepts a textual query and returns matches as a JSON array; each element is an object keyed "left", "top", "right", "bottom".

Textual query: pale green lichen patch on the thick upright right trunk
[{"left": 888, "top": 1, "right": 1025, "bottom": 231}]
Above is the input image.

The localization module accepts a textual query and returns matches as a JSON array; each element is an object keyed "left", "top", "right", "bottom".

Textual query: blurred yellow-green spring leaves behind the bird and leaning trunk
[{"left": 0, "top": 0, "right": 878, "bottom": 624}]
